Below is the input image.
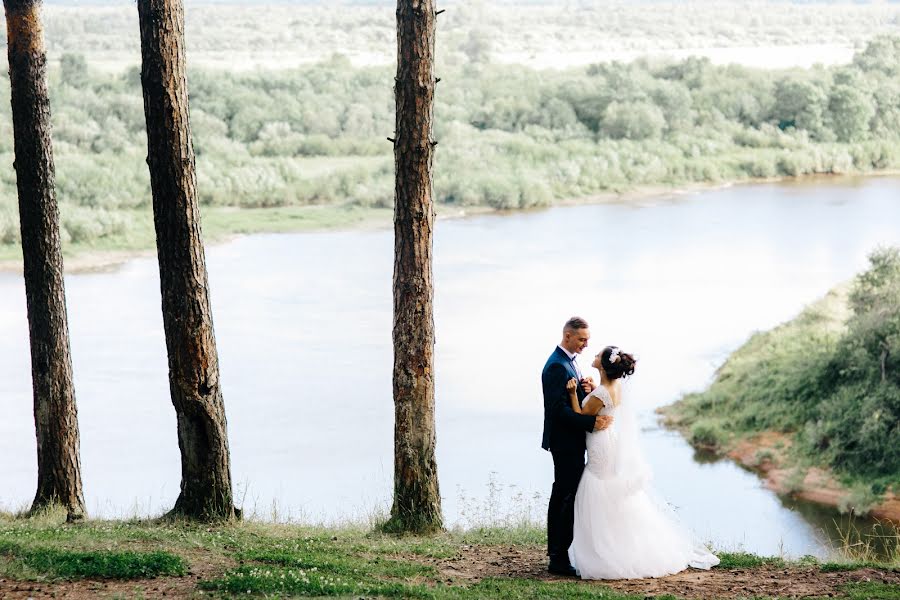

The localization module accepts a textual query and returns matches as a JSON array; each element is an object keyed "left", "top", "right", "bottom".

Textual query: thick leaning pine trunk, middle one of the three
[{"left": 137, "top": 0, "right": 235, "bottom": 520}]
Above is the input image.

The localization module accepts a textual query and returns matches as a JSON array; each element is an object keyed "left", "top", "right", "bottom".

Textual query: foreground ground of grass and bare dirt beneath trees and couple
[{"left": 0, "top": 515, "right": 900, "bottom": 600}]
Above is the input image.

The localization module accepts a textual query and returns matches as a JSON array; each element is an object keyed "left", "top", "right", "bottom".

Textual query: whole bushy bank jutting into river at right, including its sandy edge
[{"left": 658, "top": 254, "right": 900, "bottom": 525}]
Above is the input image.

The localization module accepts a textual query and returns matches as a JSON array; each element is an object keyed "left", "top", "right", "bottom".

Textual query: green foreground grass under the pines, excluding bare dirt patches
[{"left": 0, "top": 514, "right": 900, "bottom": 600}]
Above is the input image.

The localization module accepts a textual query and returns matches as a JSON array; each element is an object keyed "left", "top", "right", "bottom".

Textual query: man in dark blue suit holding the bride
[{"left": 541, "top": 317, "right": 612, "bottom": 575}]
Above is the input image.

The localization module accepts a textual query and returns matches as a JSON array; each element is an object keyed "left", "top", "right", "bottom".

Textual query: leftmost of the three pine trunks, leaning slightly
[{"left": 3, "top": 0, "right": 85, "bottom": 520}]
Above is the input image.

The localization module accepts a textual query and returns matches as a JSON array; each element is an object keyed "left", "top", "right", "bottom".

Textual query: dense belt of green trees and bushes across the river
[{"left": 0, "top": 37, "right": 900, "bottom": 247}]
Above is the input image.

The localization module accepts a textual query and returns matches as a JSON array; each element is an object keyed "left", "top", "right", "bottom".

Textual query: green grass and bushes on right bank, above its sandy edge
[{"left": 668, "top": 249, "right": 900, "bottom": 492}]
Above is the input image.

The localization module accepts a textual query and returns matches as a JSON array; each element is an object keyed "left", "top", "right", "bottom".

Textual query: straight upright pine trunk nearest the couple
[{"left": 388, "top": 0, "right": 442, "bottom": 532}]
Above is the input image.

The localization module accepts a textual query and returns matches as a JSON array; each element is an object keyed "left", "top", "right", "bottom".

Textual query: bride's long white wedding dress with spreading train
[{"left": 569, "top": 386, "right": 719, "bottom": 579}]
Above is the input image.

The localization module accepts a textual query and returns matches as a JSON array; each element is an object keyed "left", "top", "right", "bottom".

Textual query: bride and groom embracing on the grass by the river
[{"left": 541, "top": 317, "right": 719, "bottom": 579}]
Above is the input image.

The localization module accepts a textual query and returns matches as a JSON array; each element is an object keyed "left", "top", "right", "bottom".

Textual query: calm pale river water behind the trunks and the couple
[{"left": 0, "top": 178, "right": 900, "bottom": 555}]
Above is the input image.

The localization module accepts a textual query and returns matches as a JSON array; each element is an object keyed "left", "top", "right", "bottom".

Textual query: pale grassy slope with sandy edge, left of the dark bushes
[{"left": 660, "top": 285, "right": 894, "bottom": 518}]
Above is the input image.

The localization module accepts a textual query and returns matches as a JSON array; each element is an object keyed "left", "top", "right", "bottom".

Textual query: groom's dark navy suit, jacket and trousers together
[{"left": 541, "top": 346, "right": 596, "bottom": 564}]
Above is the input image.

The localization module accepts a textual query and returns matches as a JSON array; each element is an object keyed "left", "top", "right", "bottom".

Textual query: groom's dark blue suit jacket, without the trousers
[{"left": 541, "top": 346, "right": 596, "bottom": 452}]
